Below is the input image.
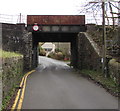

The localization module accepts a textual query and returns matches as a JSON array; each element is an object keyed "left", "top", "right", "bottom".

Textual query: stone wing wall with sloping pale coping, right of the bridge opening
[{"left": 77, "top": 32, "right": 101, "bottom": 70}]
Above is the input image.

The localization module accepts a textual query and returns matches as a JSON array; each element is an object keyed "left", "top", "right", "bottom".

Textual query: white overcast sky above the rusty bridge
[{"left": 0, "top": 0, "right": 119, "bottom": 23}]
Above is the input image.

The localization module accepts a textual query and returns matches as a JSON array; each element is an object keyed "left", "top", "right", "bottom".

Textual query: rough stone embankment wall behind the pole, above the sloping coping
[{"left": 87, "top": 24, "right": 120, "bottom": 61}]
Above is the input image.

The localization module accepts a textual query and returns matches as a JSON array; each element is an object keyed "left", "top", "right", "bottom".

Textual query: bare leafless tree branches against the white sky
[{"left": 80, "top": 0, "right": 120, "bottom": 28}]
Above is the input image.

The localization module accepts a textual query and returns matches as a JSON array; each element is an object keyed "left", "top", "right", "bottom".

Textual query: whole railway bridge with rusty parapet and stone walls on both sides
[{"left": 1, "top": 15, "right": 100, "bottom": 70}]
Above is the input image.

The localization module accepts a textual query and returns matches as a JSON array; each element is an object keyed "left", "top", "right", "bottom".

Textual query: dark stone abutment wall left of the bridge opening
[{"left": 2, "top": 23, "right": 33, "bottom": 71}]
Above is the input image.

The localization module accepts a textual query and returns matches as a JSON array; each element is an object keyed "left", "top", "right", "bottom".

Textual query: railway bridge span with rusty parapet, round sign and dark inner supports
[{"left": 27, "top": 15, "right": 86, "bottom": 66}]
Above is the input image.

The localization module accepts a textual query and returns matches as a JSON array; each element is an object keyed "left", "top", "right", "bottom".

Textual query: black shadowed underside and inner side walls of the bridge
[{"left": 32, "top": 32, "right": 78, "bottom": 67}]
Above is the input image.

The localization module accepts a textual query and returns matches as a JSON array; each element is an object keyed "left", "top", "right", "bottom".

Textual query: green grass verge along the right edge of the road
[{"left": 80, "top": 69, "right": 120, "bottom": 97}]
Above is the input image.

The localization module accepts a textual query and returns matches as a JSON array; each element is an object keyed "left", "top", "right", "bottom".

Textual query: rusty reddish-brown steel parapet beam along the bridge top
[{"left": 27, "top": 15, "right": 85, "bottom": 25}]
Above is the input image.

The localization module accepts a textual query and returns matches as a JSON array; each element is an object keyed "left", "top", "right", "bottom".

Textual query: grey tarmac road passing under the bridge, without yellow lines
[{"left": 22, "top": 56, "right": 118, "bottom": 109}]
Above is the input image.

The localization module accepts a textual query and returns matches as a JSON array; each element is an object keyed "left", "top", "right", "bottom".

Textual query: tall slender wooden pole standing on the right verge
[{"left": 102, "top": 1, "right": 107, "bottom": 77}]
